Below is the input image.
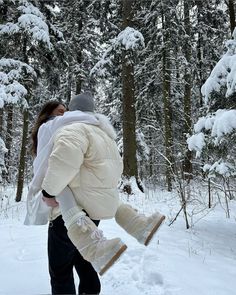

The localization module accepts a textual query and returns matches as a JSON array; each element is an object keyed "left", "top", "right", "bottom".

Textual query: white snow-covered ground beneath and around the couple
[{"left": 0, "top": 186, "right": 236, "bottom": 295}]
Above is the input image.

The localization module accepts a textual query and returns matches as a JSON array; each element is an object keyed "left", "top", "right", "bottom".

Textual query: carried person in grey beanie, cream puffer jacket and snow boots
[{"left": 41, "top": 92, "right": 165, "bottom": 275}]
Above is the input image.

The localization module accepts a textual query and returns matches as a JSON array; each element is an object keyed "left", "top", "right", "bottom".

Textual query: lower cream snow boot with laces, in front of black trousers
[{"left": 68, "top": 215, "right": 127, "bottom": 275}]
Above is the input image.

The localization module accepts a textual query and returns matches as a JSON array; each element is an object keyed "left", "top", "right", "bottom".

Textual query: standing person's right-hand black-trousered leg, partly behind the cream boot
[{"left": 74, "top": 220, "right": 101, "bottom": 295}]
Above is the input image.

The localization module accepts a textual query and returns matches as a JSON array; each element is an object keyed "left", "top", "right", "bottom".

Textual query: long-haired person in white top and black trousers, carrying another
[{"left": 25, "top": 100, "right": 101, "bottom": 295}]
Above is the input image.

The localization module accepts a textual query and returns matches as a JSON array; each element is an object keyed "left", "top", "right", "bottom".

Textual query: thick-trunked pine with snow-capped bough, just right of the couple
[{"left": 92, "top": 1, "right": 144, "bottom": 194}]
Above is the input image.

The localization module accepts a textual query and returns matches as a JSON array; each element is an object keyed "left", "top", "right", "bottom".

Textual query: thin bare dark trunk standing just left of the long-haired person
[{"left": 15, "top": 109, "right": 29, "bottom": 202}]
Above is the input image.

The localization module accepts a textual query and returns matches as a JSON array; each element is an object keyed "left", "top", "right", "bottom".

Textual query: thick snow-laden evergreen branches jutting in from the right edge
[{"left": 187, "top": 30, "right": 236, "bottom": 178}]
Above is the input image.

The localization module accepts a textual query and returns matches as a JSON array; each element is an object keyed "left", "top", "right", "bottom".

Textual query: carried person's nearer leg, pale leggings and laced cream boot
[{"left": 56, "top": 187, "right": 127, "bottom": 275}]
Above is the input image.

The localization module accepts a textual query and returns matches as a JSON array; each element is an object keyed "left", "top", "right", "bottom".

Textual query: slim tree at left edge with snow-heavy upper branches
[{"left": 0, "top": 0, "right": 61, "bottom": 201}]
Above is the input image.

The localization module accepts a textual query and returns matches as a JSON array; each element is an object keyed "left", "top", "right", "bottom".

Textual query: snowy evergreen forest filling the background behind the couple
[{"left": 0, "top": 0, "right": 236, "bottom": 228}]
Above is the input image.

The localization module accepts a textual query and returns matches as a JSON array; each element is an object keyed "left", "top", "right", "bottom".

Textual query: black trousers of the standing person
[{"left": 48, "top": 216, "right": 101, "bottom": 294}]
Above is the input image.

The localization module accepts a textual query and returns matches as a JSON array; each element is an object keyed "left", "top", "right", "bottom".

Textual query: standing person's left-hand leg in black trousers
[{"left": 48, "top": 216, "right": 77, "bottom": 294}]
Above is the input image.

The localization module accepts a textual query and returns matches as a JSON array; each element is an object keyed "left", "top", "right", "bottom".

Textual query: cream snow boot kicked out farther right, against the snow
[{"left": 115, "top": 204, "right": 165, "bottom": 246}]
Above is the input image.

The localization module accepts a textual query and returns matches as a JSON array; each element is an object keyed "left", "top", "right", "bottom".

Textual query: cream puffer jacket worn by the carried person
[{"left": 42, "top": 117, "right": 123, "bottom": 219}]
